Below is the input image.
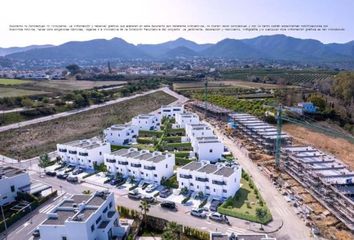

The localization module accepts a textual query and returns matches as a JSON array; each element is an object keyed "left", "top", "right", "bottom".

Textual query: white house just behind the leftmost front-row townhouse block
[{"left": 103, "top": 124, "right": 139, "bottom": 145}]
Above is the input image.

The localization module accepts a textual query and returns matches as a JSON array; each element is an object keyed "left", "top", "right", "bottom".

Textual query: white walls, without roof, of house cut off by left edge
[{"left": 0, "top": 172, "right": 31, "bottom": 205}]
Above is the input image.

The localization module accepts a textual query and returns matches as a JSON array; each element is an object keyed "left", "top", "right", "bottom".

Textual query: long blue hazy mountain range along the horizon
[{"left": 0, "top": 35, "right": 354, "bottom": 62}]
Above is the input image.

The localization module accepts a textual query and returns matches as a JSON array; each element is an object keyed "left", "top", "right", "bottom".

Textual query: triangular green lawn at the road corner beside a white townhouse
[{"left": 218, "top": 174, "right": 272, "bottom": 224}]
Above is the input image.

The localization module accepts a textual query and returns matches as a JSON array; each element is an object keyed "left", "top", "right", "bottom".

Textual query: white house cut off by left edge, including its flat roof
[{"left": 0, "top": 166, "right": 31, "bottom": 206}]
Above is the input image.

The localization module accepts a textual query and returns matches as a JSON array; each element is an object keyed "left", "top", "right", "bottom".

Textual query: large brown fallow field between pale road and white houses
[{"left": 0, "top": 92, "right": 176, "bottom": 159}]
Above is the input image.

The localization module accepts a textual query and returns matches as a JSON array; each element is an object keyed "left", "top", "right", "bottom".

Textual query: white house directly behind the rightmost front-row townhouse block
[{"left": 192, "top": 136, "right": 224, "bottom": 162}]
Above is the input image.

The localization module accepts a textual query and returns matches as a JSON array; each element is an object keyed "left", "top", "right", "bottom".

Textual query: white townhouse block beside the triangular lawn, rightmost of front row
[{"left": 177, "top": 161, "right": 241, "bottom": 198}]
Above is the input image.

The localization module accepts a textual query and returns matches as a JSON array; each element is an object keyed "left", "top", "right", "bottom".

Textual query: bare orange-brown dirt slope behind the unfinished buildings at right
[{"left": 283, "top": 124, "right": 354, "bottom": 169}]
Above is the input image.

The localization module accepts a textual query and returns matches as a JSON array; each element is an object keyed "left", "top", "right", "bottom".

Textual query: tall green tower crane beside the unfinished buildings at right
[{"left": 264, "top": 104, "right": 354, "bottom": 168}]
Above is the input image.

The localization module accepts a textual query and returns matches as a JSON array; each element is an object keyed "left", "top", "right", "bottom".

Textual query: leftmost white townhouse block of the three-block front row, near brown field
[{"left": 57, "top": 138, "right": 111, "bottom": 169}]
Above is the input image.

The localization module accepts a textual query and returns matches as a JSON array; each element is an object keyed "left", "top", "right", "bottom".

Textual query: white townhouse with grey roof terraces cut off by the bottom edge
[{"left": 38, "top": 192, "right": 125, "bottom": 240}]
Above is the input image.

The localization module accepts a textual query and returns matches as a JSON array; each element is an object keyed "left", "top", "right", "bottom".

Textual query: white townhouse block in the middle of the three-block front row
[{"left": 104, "top": 148, "right": 175, "bottom": 183}]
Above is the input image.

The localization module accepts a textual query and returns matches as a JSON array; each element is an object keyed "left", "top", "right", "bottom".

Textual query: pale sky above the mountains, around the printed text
[{"left": 0, "top": 0, "right": 354, "bottom": 47}]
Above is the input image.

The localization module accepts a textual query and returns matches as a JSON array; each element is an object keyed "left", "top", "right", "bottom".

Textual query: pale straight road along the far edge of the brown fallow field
[{"left": 0, "top": 87, "right": 185, "bottom": 132}]
